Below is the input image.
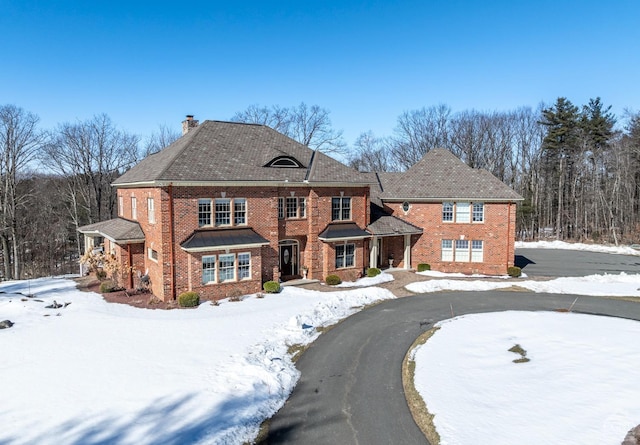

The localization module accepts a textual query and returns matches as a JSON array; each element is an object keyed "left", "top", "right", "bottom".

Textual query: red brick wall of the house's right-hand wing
[{"left": 385, "top": 202, "right": 516, "bottom": 275}]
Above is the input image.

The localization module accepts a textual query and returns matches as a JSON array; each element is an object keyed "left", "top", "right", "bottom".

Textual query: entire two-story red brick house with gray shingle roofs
[{"left": 79, "top": 116, "right": 522, "bottom": 300}]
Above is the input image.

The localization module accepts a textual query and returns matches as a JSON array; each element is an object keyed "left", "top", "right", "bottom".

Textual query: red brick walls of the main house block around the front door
[{"left": 118, "top": 182, "right": 369, "bottom": 300}]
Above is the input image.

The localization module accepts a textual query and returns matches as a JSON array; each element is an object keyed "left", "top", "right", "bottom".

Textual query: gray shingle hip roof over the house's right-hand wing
[{"left": 372, "top": 148, "right": 523, "bottom": 201}]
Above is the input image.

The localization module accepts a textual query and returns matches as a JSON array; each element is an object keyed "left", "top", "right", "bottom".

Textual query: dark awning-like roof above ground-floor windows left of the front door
[{"left": 180, "top": 227, "right": 269, "bottom": 252}]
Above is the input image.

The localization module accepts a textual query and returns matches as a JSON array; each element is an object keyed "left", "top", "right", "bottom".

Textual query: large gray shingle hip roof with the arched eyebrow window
[{"left": 114, "top": 121, "right": 366, "bottom": 186}]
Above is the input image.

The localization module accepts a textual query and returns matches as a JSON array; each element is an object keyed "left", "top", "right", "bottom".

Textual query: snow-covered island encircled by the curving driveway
[{"left": 414, "top": 312, "right": 640, "bottom": 445}]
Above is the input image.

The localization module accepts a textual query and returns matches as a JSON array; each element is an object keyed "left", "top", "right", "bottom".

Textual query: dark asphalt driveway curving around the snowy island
[{"left": 265, "top": 249, "right": 640, "bottom": 445}]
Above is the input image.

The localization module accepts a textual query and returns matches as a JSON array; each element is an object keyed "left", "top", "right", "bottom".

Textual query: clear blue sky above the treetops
[{"left": 0, "top": 0, "right": 640, "bottom": 143}]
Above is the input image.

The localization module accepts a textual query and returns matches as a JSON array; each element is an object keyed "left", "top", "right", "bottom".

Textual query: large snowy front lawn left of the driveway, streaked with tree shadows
[{"left": 0, "top": 279, "right": 393, "bottom": 445}]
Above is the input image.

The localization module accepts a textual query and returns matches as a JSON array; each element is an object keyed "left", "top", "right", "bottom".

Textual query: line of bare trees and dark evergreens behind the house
[{"left": 0, "top": 98, "right": 640, "bottom": 279}]
